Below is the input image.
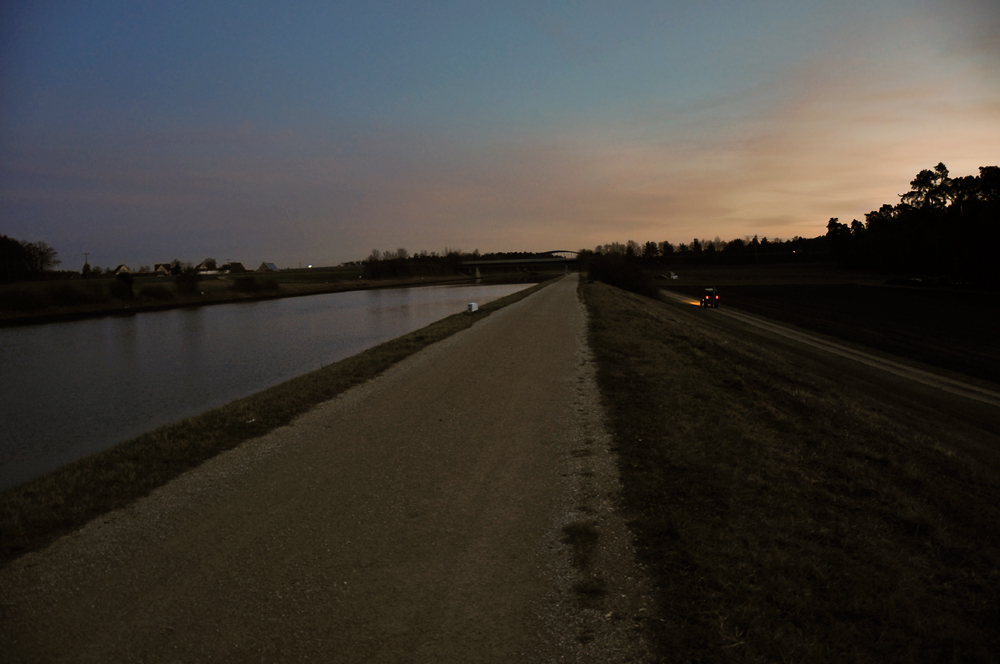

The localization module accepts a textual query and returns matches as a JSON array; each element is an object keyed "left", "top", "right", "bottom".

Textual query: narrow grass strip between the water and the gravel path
[{"left": 0, "top": 281, "right": 552, "bottom": 566}]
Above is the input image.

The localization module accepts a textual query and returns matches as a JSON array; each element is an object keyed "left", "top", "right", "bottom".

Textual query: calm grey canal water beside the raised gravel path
[{"left": 0, "top": 284, "right": 530, "bottom": 488}]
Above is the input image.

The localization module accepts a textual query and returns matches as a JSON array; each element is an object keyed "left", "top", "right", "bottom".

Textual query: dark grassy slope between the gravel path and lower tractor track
[{"left": 581, "top": 283, "right": 1000, "bottom": 663}]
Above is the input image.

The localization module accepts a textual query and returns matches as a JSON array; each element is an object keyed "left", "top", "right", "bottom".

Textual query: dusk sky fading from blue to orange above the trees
[{"left": 0, "top": 0, "right": 1000, "bottom": 269}]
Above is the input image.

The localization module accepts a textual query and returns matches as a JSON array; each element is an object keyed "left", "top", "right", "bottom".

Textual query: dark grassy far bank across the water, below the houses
[{"left": 0, "top": 267, "right": 545, "bottom": 325}]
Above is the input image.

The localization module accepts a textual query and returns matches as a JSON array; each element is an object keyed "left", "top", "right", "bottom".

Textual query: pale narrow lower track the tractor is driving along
[{"left": 660, "top": 290, "right": 1000, "bottom": 406}]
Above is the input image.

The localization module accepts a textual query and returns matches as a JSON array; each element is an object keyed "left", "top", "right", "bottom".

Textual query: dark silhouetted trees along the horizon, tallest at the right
[{"left": 0, "top": 163, "right": 1000, "bottom": 283}]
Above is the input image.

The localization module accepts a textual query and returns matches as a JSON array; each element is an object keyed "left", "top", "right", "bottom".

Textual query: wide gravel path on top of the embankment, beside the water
[{"left": 0, "top": 276, "right": 648, "bottom": 662}]
